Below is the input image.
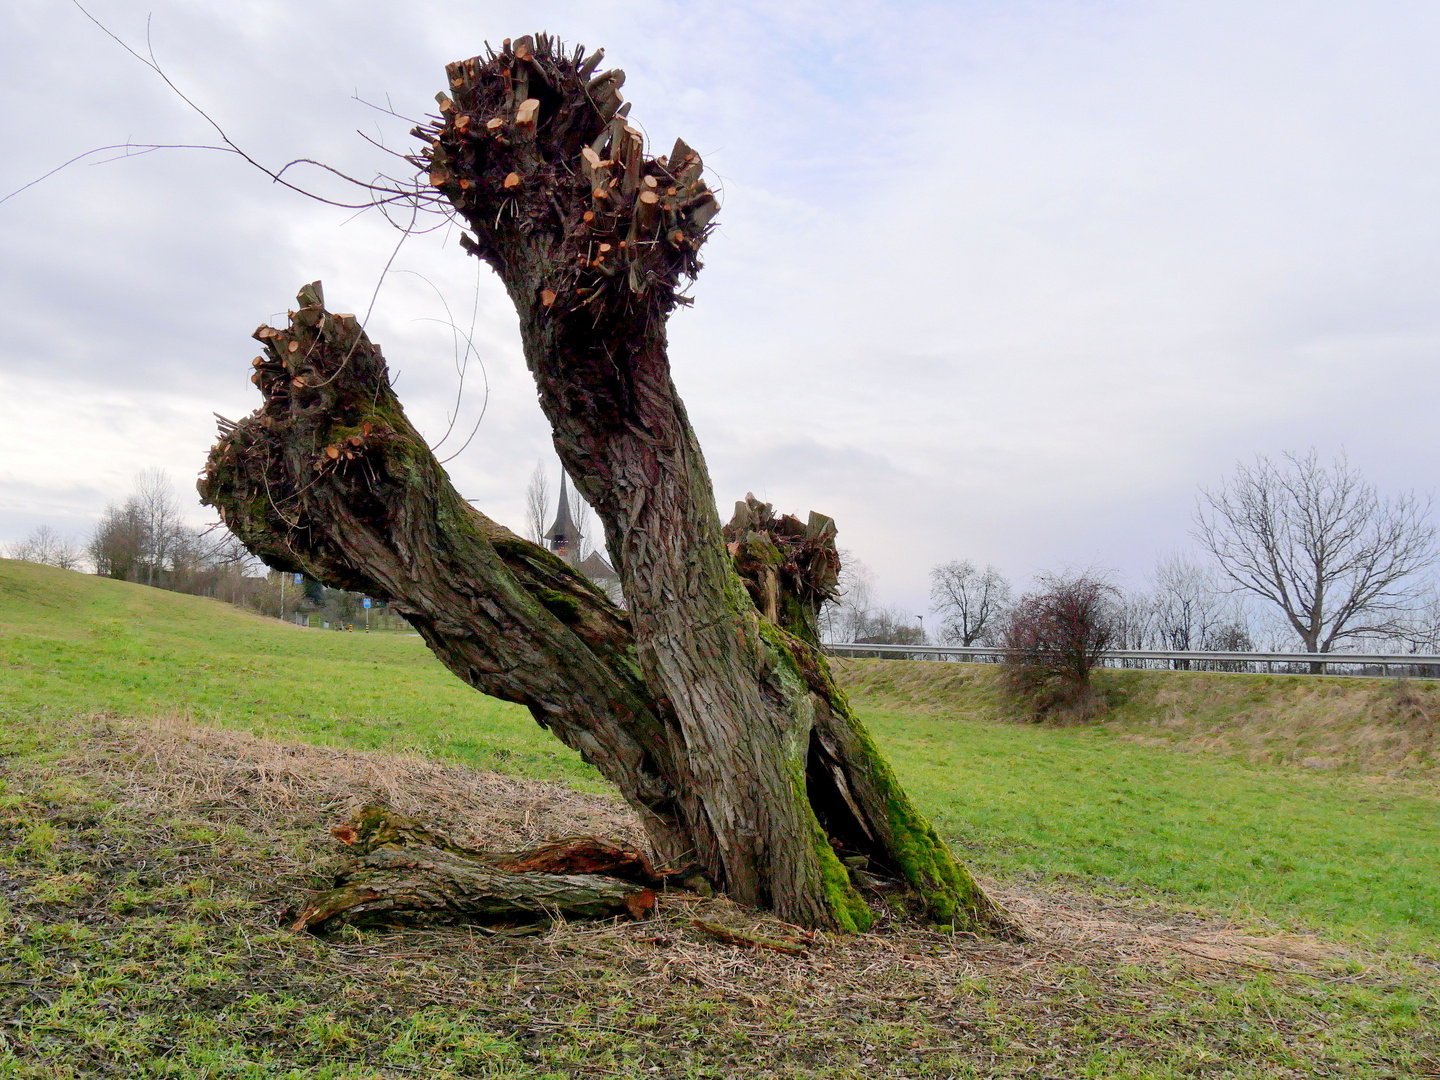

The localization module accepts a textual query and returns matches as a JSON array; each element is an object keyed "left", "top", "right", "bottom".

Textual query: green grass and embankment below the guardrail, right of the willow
[{"left": 844, "top": 661, "right": 1440, "bottom": 950}]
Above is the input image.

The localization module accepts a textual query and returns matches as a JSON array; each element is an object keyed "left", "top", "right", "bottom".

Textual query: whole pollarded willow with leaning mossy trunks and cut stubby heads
[{"left": 200, "top": 35, "right": 1018, "bottom": 935}]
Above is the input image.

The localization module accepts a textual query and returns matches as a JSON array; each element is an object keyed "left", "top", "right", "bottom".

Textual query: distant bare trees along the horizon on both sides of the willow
[{"left": 9, "top": 451, "right": 1440, "bottom": 654}]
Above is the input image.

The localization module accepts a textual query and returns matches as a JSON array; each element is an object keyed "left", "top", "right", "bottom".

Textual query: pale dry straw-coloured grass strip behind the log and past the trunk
[{"left": 42, "top": 719, "right": 1393, "bottom": 991}]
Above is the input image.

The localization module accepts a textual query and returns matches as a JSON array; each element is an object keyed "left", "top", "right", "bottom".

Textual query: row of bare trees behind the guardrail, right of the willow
[{"left": 824, "top": 451, "right": 1440, "bottom": 654}]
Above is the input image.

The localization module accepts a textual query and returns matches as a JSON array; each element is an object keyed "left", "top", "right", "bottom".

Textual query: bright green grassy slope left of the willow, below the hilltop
[{"left": 0, "top": 560, "right": 599, "bottom": 788}]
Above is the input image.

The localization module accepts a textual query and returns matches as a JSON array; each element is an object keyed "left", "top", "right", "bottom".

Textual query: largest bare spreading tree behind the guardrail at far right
[{"left": 1195, "top": 449, "right": 1436, "bottom": 668}]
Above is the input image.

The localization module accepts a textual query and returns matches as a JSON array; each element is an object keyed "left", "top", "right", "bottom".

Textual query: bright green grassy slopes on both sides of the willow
[{"left": 0, "top": 562, "right": 1440, "bottom": 950}]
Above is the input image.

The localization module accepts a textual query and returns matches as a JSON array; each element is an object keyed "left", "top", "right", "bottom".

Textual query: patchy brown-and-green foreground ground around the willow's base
[{"left": 0, "top": 720, "right": 1440, "bottom": 1080}]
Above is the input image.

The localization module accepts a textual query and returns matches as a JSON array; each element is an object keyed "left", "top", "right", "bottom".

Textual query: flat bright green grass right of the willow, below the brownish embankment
[{"left": 863, "top": 710, "right": 1440, "bottom": 949}]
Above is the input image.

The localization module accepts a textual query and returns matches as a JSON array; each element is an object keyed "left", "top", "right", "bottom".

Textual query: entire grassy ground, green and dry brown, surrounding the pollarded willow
[{"left": 0, "top": 562, "right": 1440, "bottom": 1080}]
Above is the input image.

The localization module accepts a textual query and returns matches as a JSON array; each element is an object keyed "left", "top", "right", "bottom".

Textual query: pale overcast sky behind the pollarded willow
[{"left": 0, "top": 0, "right": 1440, "bottom": 611}]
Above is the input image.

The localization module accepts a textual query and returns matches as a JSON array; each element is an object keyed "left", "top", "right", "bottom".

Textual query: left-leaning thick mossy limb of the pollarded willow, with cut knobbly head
[{"left": 199, "top": 282, "right": 706, "bottom": 863}]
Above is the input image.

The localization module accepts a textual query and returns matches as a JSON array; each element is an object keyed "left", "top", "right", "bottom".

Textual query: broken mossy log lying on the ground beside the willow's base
[{"left": 291, "top": 805, "right": 665, "bottom": 933}]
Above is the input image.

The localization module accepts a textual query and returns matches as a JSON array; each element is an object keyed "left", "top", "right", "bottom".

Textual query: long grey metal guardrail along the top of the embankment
[{"left": 825, "top": 642, "right": 1440, "bottom": 678}]
